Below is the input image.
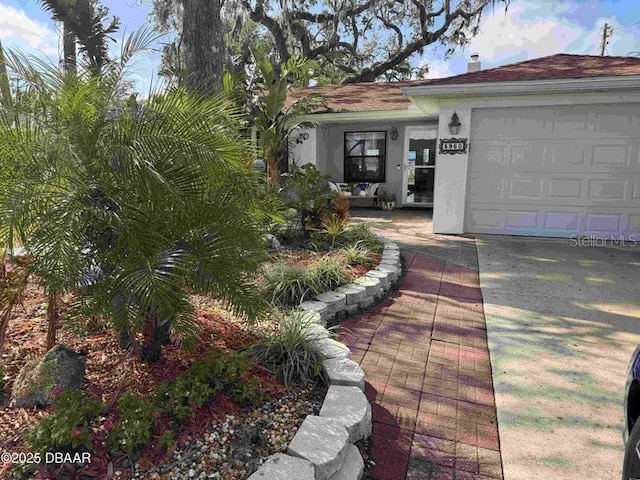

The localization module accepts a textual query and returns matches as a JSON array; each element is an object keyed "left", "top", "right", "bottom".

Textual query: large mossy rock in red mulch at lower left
[{"left": 11, "top": 345, "right": 84, "bottom": 407}]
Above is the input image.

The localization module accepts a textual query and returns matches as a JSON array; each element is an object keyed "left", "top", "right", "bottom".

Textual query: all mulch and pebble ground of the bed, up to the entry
[{"left": 0, "top": 219, "right": 380, "bottom": 479}]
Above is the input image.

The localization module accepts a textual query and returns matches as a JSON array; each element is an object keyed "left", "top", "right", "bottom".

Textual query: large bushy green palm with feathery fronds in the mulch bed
[{"left": 0, "top": 29, "right": 264, "bottom": 360}]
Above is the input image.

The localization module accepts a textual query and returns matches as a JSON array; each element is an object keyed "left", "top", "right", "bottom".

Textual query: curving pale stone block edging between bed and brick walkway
[{"left": 249, "top": 236, "right": 402, "bottom": 480}]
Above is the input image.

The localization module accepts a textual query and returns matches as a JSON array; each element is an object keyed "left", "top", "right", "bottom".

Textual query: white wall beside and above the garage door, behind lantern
[{"left": 430, "top": 92, "right": 640, "bottom": 234}]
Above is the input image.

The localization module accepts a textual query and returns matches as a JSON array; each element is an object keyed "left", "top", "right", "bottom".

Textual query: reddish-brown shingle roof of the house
[{"left": 287, "top": 53, "right": 640, "bottom": 113}]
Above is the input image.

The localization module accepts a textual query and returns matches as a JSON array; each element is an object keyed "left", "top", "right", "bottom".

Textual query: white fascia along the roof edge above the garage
[{"left": 402, "top": 75, "right": 640, "bottom": 97}]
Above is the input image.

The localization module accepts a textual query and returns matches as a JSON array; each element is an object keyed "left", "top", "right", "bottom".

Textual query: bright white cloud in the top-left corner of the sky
[{"left": 0, "top": 4, "right": 58, "bottom": 54}]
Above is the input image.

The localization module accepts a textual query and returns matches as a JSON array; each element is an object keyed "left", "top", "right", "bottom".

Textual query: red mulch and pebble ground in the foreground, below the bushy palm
[{"left": 0, "top": 274, "right": 324, "bottom": 479}]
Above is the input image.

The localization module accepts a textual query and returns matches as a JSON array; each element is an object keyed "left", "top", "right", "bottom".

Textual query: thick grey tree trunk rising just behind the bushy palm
[{"left": 182, "top": 0, "right": 227, "bottom": 96}]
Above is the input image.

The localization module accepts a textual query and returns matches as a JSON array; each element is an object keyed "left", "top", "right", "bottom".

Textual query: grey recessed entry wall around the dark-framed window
[{"left": 316, "top": 120, "right": 437, "bottom": 206}]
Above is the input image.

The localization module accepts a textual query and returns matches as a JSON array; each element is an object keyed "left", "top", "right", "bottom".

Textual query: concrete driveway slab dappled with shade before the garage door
[{"left": 476, "top": 236, "right": 640, "bottom": 480}]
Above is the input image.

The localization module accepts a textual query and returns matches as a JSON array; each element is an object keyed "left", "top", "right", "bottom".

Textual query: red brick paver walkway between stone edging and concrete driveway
[{"left": 339, "top": 251, "right": 502, "bottom": 480}]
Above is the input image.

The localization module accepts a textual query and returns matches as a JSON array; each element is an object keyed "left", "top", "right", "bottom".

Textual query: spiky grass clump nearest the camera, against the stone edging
[{"left": 254, "top": 312, "right": 322, "bottom": 386}]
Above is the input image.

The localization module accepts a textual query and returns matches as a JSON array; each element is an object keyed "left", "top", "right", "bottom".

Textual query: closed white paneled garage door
[{"left": 465, "top": 105, "right": 640, "bottom": 240}]
